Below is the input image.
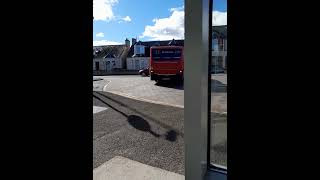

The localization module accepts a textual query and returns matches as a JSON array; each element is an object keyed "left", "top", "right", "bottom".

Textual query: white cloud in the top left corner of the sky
[{"left": 93, "top": 0, "right": 118, "bottom": 21}]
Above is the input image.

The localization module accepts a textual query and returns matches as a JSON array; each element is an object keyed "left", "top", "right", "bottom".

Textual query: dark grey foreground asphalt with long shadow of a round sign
[{"left": 93, "top": 91, "right": 227, "bottom": 174}]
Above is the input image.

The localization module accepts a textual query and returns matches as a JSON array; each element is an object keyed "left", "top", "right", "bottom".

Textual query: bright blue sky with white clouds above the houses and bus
[{"left": 93, "top": 0, "right": 227, "bottom": 45}]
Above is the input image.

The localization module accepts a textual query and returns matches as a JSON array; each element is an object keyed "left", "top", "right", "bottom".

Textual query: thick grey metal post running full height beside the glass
[{"left": 184, "top": 0, "right": 211, "bottom": 180}]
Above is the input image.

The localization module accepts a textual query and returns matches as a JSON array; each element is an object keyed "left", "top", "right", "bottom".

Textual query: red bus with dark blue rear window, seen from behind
[{"left": 150, "top": 46, "right": 184, "bottom": 81}]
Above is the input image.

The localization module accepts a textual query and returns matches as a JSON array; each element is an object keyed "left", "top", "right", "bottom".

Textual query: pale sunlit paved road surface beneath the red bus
[{"left": 93, "top": 74, "right": 227, "bottom": 113}]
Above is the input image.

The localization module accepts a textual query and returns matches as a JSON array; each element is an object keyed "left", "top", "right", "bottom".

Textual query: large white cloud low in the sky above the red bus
[{"left": 140, "top": 6, "right": 227, "bottom": 40}]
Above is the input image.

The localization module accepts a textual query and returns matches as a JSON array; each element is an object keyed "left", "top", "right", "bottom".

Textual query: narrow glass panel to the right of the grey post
[{"left": 210, "top": 0, "right": 227, "bottom": 166}]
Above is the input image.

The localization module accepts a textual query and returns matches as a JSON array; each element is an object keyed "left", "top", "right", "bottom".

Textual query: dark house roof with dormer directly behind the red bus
[{"left": 128, "top": 40, "right": 184, "bottom": 57}]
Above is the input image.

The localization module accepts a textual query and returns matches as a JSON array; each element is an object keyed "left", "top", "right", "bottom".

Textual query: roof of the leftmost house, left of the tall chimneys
[{"left": 93, "top": 45, "right": 128, "bottom": 58}]
